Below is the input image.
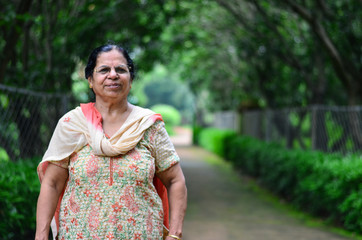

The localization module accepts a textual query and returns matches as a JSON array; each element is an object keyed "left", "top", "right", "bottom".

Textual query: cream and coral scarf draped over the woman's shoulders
[{"left": 37, "top": 103, "right": 169, "bottom": 237}]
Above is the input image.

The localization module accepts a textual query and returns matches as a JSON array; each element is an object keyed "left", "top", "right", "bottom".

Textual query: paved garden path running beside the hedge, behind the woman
[{"left": 172, "top": 128, "right": 354, "bottom": 240}]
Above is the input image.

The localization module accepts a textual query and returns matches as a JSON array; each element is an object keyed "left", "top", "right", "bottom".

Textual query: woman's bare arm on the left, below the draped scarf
[{"left": 35, "top": 163, "right": 68, "bottom": 240}]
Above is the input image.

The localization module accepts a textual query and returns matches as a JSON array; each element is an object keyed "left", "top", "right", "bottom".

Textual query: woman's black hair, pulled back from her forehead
[{"left": 84, "top": 43, "right": 136, "bottom": 81}]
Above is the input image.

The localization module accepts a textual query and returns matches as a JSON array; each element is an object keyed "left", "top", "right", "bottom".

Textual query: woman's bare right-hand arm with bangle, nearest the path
[{"left": 157, "top": 163, "right": 187, "bottom": 240}]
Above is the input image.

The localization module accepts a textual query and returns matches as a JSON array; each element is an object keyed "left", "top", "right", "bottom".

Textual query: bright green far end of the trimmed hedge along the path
[{"left": 198, "top": 128, "right": 235, "bottom": 156}]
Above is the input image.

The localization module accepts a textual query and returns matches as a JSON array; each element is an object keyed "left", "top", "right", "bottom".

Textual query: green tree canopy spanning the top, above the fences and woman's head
[{"left": 0, "top": 0, "right": 362, "bottom": 110}]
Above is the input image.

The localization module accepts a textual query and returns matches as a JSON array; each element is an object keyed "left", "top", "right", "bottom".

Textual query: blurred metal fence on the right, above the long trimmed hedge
[{"left": 240, "top": 106, "right": 362, "bottom": 153}]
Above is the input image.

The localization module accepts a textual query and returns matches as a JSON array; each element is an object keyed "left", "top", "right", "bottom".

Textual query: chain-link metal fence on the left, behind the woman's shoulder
[{"left": 0, "top": 84, "right": 74, "bottom": 161}]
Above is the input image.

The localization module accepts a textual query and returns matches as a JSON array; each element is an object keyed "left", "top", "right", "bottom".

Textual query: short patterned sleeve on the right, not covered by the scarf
[{"left": 153, "top": 121, "right": 180, "bottom": 173}]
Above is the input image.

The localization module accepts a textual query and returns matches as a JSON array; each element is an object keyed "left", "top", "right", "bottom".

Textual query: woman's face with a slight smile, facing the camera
[{"left": 88, "top": 49, "right": 131, "bottom": 101}]
